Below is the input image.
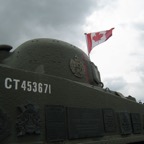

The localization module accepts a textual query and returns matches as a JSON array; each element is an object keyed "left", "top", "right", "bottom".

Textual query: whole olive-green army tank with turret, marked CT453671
[{"left": 0, "top": 38, "right": 144, "bottom": 144}]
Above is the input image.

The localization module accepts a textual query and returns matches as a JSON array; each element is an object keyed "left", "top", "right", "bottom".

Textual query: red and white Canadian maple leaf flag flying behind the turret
[{"left": 86, "top": 28, "right": 114, "bottom": 54}]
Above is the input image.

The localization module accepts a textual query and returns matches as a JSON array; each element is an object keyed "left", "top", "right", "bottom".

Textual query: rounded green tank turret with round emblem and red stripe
[{"left": 3, "top": 38, "right": 102, "bottom": 86}]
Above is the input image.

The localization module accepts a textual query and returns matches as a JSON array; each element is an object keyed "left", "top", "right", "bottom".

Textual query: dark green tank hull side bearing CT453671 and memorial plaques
[{"left": 0, "top": 65, "right": 144, "bottom": 144}]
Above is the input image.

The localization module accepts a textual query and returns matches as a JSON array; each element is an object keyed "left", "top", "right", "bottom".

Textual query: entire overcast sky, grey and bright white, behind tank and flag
[{"left": 0, "top": 0, "right": 144, "bottom": 102}]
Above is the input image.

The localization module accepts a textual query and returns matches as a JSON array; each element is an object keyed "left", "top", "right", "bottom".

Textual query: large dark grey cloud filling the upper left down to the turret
[{"left": 0, "top": 0, "right": 115, "bottom": 46}]
